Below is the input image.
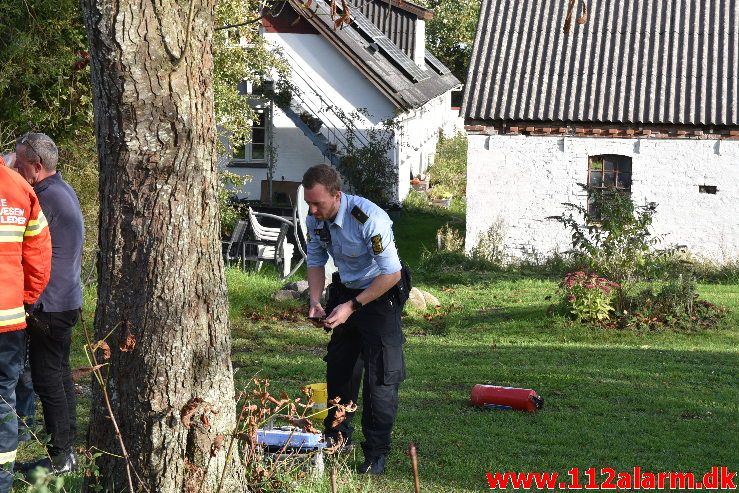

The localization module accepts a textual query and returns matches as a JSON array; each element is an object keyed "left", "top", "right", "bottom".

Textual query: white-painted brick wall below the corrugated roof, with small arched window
[{"left": 466, "top": 135, "right": 739, "bottom": 262}]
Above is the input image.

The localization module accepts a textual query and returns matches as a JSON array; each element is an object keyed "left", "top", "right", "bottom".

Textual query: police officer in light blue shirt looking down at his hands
[{"left": 302, "top": 165, "right": 410, "bottom": 474}]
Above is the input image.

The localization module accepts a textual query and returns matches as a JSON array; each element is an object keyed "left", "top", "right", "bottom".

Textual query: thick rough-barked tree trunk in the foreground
[{"left": 82, "top": 0, "right": 238, "bottom": 493}]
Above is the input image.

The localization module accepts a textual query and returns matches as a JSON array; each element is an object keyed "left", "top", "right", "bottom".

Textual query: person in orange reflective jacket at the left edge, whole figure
[{"left": 0, "top": 156, "right": 51, "bottom": 493}]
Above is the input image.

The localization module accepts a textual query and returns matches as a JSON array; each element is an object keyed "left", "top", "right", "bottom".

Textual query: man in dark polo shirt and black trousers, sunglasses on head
[{"left": 15, "top": 133, "right": 84, "bottom": 474}]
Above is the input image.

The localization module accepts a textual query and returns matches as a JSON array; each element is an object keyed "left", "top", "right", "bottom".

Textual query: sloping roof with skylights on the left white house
[{"left": 289, "top": 0, "right": 459, "bottom": 110}]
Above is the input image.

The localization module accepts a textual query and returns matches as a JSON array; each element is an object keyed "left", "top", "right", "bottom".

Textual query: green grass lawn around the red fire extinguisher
[{"left": 15, "top": 206, "right": 739, "bottom": 492}]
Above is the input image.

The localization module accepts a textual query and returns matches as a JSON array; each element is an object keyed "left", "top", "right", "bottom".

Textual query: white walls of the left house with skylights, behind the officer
[{"left": 222, "top": 33, "right": 460, "bottom": 200}]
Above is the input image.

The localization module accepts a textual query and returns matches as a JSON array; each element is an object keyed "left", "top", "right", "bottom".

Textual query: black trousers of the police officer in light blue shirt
[{"left": 324, "top": 288, "right": 405, "bottom": 457}]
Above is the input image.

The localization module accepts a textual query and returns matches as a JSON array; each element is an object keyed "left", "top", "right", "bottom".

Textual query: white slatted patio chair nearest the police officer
[{"left": 244, "top": 207, "right": 295, "bottom": 278}]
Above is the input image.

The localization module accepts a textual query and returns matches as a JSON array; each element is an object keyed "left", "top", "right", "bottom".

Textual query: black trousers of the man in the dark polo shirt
[{"left": 28, "top": 310, "right": 79, "bottom": 457}]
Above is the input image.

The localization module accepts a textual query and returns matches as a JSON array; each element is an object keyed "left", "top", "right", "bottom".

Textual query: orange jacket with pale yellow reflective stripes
[{"left": 0, "top": 157, "right": 51, "bottom": 332}]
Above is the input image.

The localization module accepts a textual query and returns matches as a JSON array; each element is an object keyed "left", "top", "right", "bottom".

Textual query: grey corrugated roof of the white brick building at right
[{"left": 462, "top": 0, "right": 739, "bottom": 126}]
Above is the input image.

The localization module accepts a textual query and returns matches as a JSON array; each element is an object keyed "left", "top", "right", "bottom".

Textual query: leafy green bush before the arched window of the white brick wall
[{"left": 553, "top": 190, "right": 722, "bottom": 330}]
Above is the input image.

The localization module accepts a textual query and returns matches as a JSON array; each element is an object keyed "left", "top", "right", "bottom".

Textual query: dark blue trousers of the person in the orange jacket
[{"left": 0, "top": 330, "right": 26, "bottom": 493}]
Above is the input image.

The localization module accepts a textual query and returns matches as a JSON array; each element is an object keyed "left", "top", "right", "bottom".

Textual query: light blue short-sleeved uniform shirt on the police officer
[{"left": 305, "top": 192, "right": 401, "bottom": 289}]
